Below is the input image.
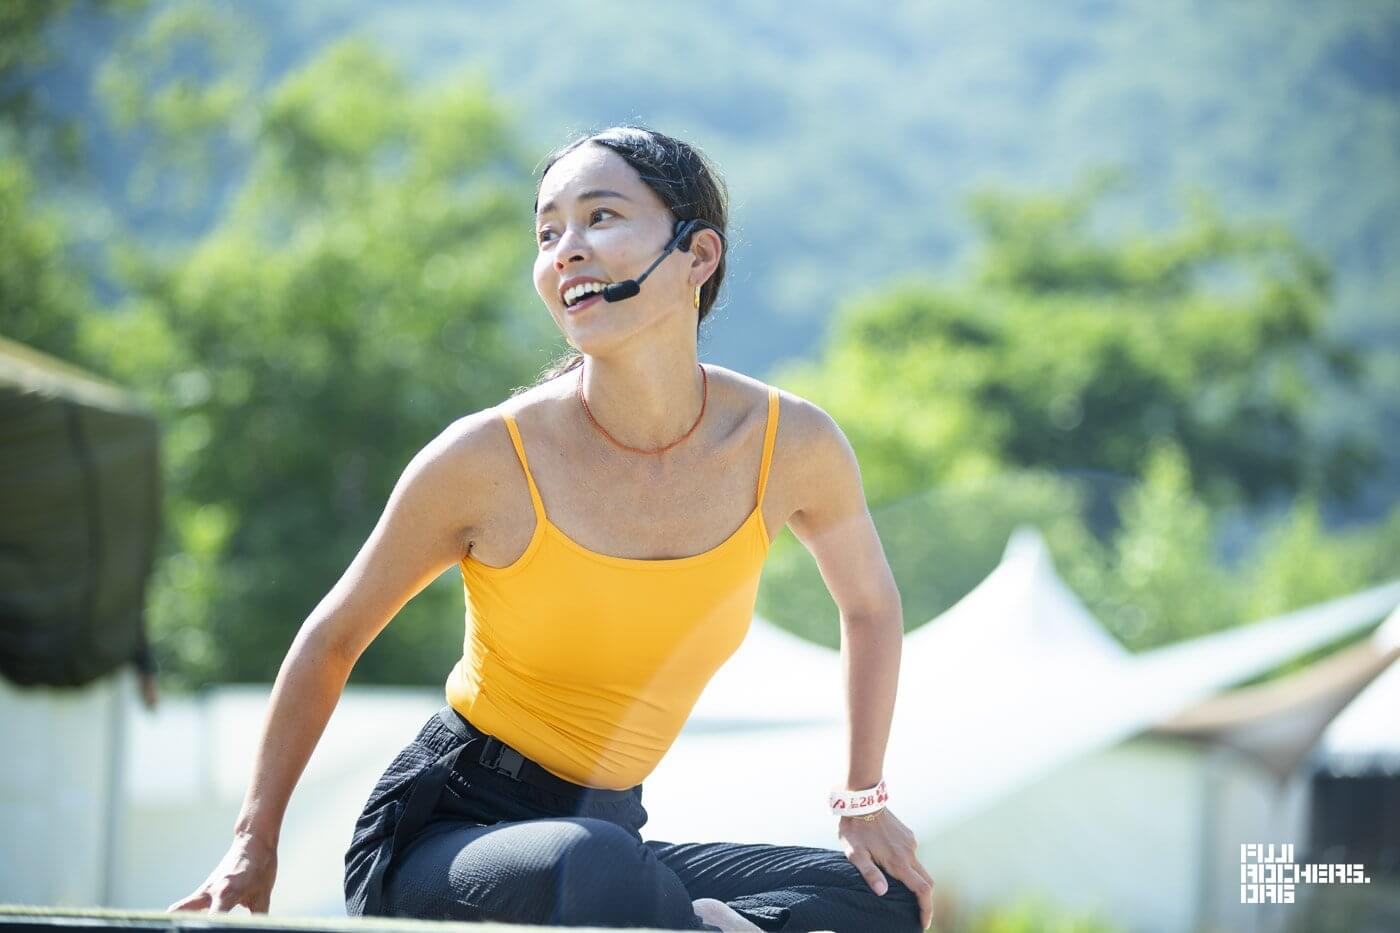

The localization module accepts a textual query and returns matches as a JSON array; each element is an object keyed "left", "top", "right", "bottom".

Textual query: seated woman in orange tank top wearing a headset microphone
[{"left": 171, "top": 126, "right": 932, "bottom": 932}]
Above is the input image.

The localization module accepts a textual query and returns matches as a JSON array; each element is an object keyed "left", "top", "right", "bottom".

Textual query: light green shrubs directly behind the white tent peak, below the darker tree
[{"left": 759, "top": 431, "right": 1400, "bottom": 652}]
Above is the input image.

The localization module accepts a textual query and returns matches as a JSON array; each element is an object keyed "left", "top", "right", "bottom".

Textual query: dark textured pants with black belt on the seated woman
[{"left": 346, "top": 707, "right": 921, "bottom": 933}]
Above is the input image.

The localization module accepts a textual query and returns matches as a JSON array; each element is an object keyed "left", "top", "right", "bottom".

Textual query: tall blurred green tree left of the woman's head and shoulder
[{"left": 80, "top": 32, "right": 546, "bottom": 684}]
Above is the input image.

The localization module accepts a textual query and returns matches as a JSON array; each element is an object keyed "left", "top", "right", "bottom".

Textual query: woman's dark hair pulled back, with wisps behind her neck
[{"left": 520, "top": 125, "right": 729, "bottom": 385}]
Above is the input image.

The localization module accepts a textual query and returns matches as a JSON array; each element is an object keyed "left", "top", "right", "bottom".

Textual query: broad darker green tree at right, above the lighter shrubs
[{"left": 778, "top": 177, "right": 1373, "bottom": 502}]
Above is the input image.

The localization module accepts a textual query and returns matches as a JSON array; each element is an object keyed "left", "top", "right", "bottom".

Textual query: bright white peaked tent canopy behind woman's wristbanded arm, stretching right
[{"left": 645, "top": 531, "right": 1400, "bottom": 846}]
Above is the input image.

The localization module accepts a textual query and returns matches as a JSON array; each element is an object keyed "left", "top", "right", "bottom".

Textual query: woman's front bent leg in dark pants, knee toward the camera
[{"left": 384, "top": 817, "right": 704, "bottom": 930}]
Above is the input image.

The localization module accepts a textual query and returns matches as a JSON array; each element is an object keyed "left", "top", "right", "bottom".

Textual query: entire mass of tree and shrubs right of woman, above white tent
[{"left": 759, "top": 175, "right": 1400, "bottom": 652}]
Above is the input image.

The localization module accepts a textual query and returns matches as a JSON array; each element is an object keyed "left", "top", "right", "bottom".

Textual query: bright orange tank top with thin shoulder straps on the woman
[{"left": 447, "top": 388, "right": 778, "bottom": 790}]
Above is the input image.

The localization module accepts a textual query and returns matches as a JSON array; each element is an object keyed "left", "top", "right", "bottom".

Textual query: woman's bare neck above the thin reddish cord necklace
[{"left": 574, "top": 346, "right": 704, "bottom": 450}]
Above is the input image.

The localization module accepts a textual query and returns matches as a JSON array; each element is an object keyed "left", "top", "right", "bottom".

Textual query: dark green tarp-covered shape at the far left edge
[{"left": 0, "top": 338, "right": 160, "bottom": 686}]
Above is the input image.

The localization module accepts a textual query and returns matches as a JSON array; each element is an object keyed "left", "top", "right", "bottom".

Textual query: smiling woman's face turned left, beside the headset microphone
[{"left": 535, "top": 143, "right": 700, "bottom": 353}]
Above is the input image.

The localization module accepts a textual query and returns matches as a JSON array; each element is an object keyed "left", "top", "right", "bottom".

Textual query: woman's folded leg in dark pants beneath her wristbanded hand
[{"left": 644, "top": 839, "right": 924, "bottom": 933}]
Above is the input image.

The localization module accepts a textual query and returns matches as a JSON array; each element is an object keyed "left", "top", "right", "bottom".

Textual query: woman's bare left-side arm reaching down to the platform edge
[{"left": 169, "top": 412, "right": 491, "bottom": 912}]
